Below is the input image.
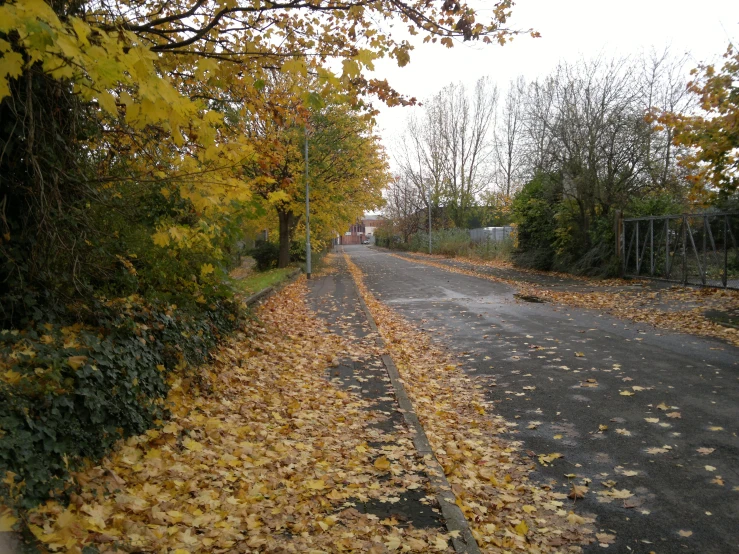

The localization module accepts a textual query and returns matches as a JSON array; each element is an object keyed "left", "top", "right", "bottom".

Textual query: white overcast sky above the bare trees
[{"left": 375, "top": 0, "right": 739, "bottom": 166}]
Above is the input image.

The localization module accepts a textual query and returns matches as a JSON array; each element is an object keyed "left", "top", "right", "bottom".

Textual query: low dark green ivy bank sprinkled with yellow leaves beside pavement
[{"left": 0, "top": 297, "right": 239, "bottom": 508}]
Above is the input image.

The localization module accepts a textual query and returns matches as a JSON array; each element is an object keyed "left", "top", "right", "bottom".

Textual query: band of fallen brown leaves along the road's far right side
[{"left": 392, "top": 254, "right": 739, "bottom": 346}]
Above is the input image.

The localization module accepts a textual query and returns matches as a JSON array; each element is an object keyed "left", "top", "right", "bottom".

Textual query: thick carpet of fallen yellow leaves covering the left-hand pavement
[{"left": 14, "top": 279, "right": 460, "bottom": 554}]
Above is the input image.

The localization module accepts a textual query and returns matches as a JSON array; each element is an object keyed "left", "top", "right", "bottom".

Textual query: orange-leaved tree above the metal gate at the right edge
[{"left": 659, "top": 45, "right": 739, "bottom": 198}]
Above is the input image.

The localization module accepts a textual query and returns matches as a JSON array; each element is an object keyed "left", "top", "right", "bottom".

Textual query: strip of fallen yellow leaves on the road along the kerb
[{"left": 345, "top": 257, "right": 594, "bottom": 552}]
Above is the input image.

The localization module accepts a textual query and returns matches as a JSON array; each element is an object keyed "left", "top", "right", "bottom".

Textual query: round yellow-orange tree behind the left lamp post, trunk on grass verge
[{"left": 245, "top": 92, "right": 388, "bottom": 267}]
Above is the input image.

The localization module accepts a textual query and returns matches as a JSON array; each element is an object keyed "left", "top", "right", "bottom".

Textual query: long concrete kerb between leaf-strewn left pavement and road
[{"left": 352, "top": 258, "right": 480, "bottom": 554}]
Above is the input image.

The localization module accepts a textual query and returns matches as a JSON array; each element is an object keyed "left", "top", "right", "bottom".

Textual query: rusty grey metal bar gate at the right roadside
[{"left": 620, "top": 213, "right": 739, "bottom": 289}]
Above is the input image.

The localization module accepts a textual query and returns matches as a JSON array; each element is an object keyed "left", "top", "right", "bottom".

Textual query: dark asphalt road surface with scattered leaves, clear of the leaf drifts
[{"left": 344, "top": 246, "right": 739, "bottom": 554}]
